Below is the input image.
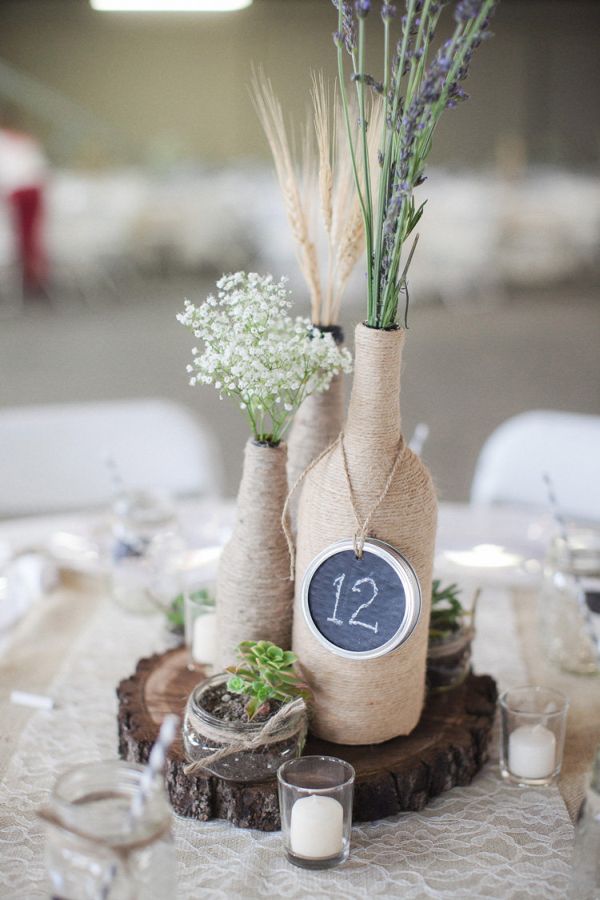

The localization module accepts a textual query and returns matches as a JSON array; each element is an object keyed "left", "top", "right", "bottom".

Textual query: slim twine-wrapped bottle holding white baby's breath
[{"left": 217, "top": 440, "right": 293, "bottom": 667}]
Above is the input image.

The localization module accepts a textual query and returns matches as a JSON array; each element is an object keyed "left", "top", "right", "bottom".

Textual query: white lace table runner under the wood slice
[{"left": 0, "top": 572, "right": 573, "bottom": 900}]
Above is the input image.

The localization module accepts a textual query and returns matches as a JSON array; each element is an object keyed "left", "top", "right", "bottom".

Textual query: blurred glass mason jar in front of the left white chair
[{"left": 111, "top": 490, "right": 184, "bottom": 613}]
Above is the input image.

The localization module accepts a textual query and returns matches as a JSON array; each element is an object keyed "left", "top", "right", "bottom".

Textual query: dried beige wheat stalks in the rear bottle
[{"left": 252, "top": 71, "right": 380, "bottom": 325}]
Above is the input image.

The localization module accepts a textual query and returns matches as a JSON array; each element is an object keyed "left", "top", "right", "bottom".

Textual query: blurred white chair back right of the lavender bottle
[{"left": 471, "top": 410, "right": 600, "bottom": 520}]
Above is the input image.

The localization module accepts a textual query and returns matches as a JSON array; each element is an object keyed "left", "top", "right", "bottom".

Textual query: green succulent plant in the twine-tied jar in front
[{"left": 226, "top": 641, "right": 312, "bottom": 719}]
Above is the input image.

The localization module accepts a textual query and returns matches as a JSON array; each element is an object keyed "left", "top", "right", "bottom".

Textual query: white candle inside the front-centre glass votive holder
[{"left": 290, "top": 794, "right": 344, "bottom": 859}]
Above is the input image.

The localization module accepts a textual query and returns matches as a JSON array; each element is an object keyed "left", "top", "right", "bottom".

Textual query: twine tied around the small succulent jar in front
[{"left": 183, "top": 697, "right": 306, "bottom": 775}]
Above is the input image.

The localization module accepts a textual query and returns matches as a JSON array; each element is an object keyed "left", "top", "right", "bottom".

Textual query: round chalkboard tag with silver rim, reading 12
[{"left": 302, "top": 538, "right": 421, "bottom": 659}]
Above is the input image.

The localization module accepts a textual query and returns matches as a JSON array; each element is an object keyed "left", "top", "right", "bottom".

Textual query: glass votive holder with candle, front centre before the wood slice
[{"left": 277, "top": 756, "right": 354, "bottom": 869}]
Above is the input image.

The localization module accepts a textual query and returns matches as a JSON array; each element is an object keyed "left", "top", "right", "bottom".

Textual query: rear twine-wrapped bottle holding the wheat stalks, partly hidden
[{"left": 287, "top": 325, "right": 345, "bottom": 531}]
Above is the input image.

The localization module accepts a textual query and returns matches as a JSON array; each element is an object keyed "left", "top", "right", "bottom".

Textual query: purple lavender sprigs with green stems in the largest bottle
[{"left": 333, "top": 0, "right": 497, "bottom": 328}]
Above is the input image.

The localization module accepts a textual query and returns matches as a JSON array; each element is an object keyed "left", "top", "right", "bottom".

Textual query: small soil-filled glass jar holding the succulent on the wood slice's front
[{"left": 183, "top": 673, "right": 307, "bottom": 781}]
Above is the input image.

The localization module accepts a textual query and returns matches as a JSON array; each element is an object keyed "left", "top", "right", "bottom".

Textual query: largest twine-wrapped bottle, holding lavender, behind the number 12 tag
[{"left": 293, "top": 325, "right": 437, "bottom": 744}]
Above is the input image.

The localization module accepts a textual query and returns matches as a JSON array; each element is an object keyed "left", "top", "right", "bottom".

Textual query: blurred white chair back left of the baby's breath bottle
[{"left": 0, "top": 399, "right": 222, "bottom": 516}]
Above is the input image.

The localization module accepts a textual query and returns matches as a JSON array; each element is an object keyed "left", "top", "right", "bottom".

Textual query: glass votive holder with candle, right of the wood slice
[{"left": 499, "top": 685, "right": 569, "bottom": 787}]
